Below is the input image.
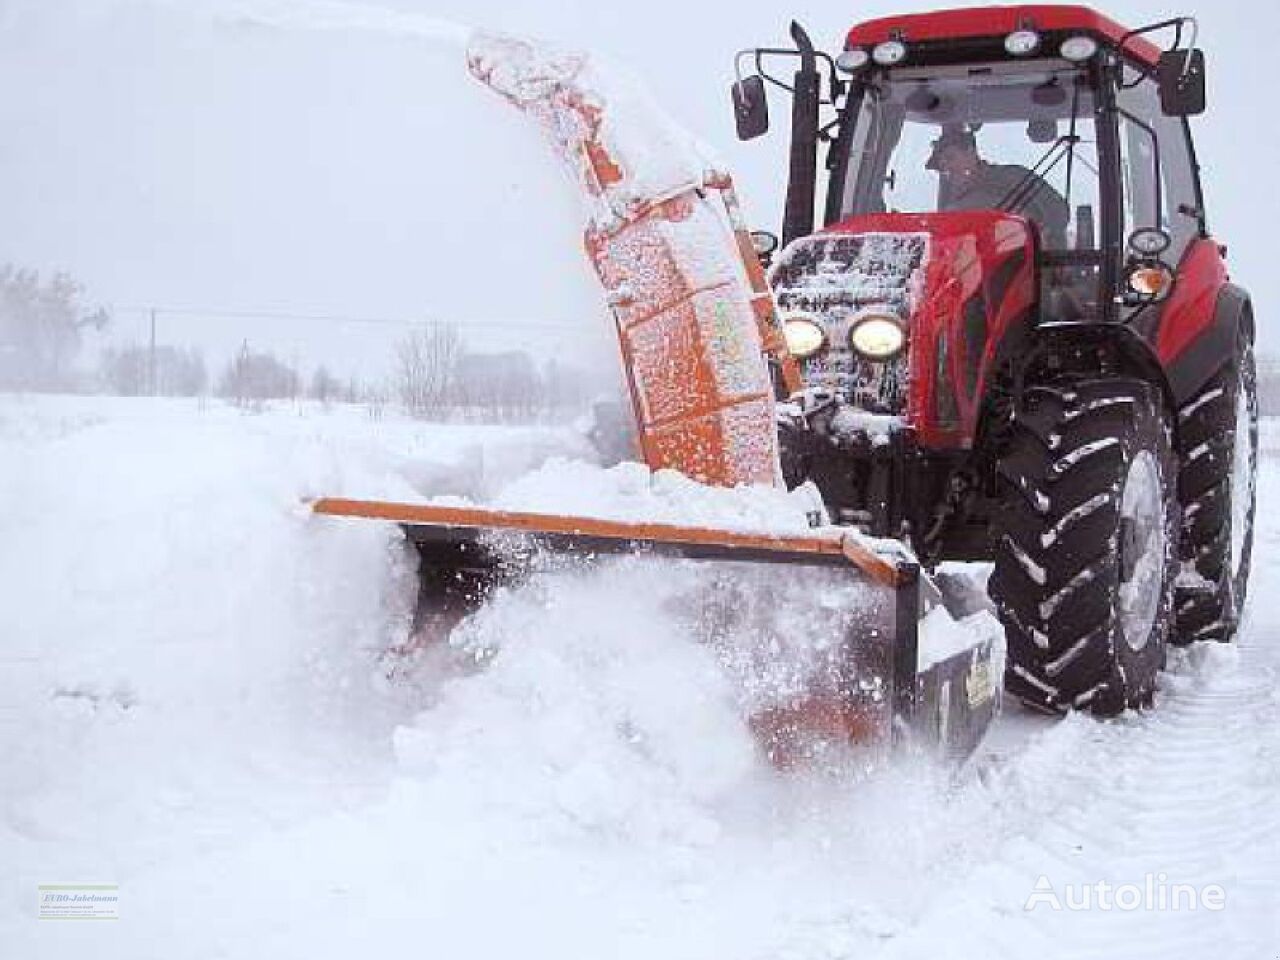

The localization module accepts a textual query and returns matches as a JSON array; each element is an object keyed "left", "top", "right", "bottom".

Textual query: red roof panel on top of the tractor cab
[{"left": 846, "top": 4, "right": 1160, "bottom": 65}]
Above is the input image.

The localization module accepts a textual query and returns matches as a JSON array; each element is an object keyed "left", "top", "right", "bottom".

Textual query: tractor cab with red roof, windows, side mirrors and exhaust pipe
[{"left": 733, "top": 6, "right": 1204, "bottom": 330}]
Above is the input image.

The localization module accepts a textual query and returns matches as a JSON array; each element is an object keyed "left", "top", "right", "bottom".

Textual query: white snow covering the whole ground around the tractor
[{"left": 0, "top": 397, "right": 1280, "bottom": 960}]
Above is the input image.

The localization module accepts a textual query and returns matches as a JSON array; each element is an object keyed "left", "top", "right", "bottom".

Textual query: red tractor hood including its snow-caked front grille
[{"left": 769, "top": 210, "right": 1036, "bottom": 447}]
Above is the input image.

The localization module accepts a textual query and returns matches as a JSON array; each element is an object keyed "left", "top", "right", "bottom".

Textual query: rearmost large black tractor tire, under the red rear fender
[{"left": 1175, "top": 333, "right": 1258, "bottom": 643}]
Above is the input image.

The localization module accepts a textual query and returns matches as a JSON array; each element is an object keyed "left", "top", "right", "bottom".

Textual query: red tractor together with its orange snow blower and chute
[{"left": 314, "top": 6, "right": 1257, "bottom": 765}]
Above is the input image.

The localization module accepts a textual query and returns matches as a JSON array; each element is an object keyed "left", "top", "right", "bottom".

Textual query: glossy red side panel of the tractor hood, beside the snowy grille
[{"left": 827, "top": 210, "right": 1036, "bottom": 449}]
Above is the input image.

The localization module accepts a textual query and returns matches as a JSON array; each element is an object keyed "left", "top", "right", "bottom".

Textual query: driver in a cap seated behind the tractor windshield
[{"left": 925, "top": 124, "right": 1070, "bottom": 250}]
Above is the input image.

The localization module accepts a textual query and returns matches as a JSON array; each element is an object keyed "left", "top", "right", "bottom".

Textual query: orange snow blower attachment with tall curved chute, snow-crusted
[{"left": 314, "top": 28, "right": 1000, "bottom": 765}]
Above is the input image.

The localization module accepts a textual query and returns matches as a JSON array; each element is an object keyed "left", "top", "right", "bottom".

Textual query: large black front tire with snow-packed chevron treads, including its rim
[{"left": 991, "top": 378, "right": 1178, "bottom": 716}]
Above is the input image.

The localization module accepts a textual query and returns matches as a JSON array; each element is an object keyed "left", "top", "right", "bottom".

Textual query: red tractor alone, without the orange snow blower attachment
[{"left": 733, "top": 6, "right": 1257, "bottom": 714}]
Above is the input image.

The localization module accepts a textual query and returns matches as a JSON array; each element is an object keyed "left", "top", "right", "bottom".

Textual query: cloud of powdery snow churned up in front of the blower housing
[{"left": 396, "top": 547, "right": 887, "bottom": 842}]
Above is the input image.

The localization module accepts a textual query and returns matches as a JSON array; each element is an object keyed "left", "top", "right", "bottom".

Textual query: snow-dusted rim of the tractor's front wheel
[{"left": 1119, "top": 451, "right": 1167, "bottom": 650}]
